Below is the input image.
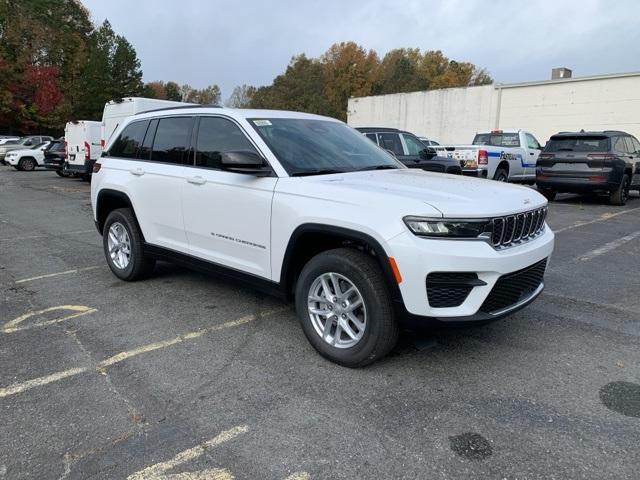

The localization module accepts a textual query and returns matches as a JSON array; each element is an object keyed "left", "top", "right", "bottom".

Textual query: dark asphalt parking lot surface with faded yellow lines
[{"left": 0, "top": 167, "right": 640, "bottom": 480}]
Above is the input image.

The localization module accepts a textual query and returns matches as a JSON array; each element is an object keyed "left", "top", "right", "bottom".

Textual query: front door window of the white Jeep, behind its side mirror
[{"left": 196, "top": 117, "right": 258, "bottom": 169}]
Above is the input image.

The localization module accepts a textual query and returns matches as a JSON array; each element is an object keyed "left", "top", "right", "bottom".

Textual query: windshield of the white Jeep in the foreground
[{"left": 249, "top": 118, "right": 403, "bottom": 175}]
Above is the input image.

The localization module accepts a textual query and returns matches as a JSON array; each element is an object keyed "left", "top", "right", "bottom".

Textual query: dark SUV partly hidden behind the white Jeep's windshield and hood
[{"left": 356, "top": 127, "right": 462, "bottom": 175}]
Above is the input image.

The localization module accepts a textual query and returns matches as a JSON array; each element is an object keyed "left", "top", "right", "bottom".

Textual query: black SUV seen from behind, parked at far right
[{"left": 536, "top": 130, "right": 640, "bottom": 205}]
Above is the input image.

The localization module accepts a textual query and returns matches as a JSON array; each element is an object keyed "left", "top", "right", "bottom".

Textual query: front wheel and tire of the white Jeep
[{"left": 295, "top": 248, "right": 398, "bottom": 368}]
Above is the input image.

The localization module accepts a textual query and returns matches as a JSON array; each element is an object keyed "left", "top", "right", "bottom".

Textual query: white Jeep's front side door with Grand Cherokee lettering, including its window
[{"left": 183, "top": 116, "right": 278, "bottom": 279}]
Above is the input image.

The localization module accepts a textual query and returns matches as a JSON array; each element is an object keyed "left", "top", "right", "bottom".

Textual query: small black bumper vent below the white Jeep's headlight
[{"left": 427, "top": 272, "right": 485, "bottom": 308}]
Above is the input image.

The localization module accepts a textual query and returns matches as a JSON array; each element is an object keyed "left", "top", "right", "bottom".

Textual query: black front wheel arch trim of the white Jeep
[{"left": 280, "top": 223, "right": 402, "bottom": 300}]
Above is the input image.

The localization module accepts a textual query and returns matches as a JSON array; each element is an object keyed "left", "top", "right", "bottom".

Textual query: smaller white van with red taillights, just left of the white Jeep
[{"left": 63, "top": 120, "right": 102, "bottom": 178}]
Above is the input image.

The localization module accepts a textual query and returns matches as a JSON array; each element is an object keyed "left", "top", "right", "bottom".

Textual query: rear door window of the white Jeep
[{"left": 151, "top": 117, "right": 193, "bottom": 165}]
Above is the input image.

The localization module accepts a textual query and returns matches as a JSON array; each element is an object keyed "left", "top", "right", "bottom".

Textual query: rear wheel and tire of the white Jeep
[{"left": 102, "top": 208, "right": 156, "bottom": 282}]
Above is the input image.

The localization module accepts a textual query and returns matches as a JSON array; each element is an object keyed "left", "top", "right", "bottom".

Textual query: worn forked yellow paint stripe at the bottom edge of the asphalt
[{"left": 127, "top": 425, "right": 249, "bottom": 480}]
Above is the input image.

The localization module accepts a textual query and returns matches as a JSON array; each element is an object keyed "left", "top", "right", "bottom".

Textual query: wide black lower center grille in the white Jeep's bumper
[{"left": 480, "top": 258, "right": 547, "bottom": 313}]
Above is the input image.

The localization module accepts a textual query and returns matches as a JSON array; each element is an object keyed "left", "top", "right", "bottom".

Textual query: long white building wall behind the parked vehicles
[{"left": 348, "top": 73, "right": 640, "bottom": 144}]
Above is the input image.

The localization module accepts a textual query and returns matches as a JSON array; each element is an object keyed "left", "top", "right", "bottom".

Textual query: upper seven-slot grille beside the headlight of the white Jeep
[{"left": 491, "top": 207, "right": 547, "bottom": 248}]
